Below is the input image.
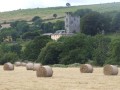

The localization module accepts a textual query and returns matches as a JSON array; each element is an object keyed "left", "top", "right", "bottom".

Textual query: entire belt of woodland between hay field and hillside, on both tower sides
[{"left": 0, "top": 9, "right": 120, "bottom": 66}]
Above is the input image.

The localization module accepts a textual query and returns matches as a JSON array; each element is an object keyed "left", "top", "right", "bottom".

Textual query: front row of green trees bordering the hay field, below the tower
[{"left": 0, "top": 33, "right": 120, "bottom": 66}]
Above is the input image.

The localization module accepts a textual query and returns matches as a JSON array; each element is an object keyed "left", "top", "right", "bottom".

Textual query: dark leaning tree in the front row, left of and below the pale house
[{"left": 24, "top": 36, "right": 51, "bottom": 61}]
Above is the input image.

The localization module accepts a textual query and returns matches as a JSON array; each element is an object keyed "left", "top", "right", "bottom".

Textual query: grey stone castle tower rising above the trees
[{"left": 65, "top": 12, "right": 80, "bottom": 34}]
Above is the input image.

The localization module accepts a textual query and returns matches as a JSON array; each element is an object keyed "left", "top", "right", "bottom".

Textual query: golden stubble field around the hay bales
[{"left": 0, "top": 66, "right": 120, "bottom": 90}]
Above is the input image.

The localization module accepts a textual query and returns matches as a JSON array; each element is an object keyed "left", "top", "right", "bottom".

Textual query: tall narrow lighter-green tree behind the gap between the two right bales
[{"left": 93, "top": 35, "right": 111, "bottom": 66}]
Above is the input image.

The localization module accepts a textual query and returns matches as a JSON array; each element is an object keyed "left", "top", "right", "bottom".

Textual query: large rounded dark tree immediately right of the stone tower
[{"left": 81, "top": 12, "right": 110, "bottom": 35}]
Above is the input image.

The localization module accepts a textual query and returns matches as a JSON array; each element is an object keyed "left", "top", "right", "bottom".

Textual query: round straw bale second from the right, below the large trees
[{"left": 80, "top": 64, "right": 93, "bottom": 73}]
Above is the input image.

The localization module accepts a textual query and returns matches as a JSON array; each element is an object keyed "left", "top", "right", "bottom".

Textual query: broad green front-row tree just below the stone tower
[{"left": 59, "top": 34, "right": 93, "bottom": 64}]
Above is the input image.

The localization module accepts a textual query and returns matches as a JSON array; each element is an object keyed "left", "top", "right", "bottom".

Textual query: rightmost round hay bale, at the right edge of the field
[{"left": 103, "top": 65, "right": 118, "bottom": 75}]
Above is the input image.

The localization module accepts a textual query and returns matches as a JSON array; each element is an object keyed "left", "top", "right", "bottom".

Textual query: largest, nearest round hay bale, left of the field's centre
[{"left": 36, "top": 66, "right": 53, "bottom": 77}]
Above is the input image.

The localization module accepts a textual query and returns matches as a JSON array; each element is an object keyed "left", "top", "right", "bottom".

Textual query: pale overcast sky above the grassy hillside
[{"left": 0, "top": 0, "right": 120, "bottom": 12}]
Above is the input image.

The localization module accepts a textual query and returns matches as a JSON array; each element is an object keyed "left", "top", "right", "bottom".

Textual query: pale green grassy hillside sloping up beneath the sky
[{"left": 0, "top": 3, "right": 120, "bottom": 22}]
